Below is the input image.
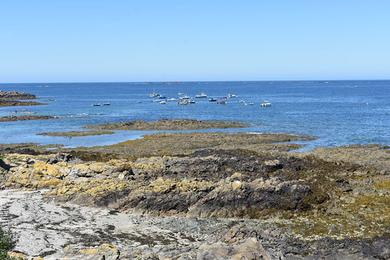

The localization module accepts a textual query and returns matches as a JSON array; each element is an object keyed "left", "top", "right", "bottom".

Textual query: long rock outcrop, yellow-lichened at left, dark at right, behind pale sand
[{"left": 0, "top": 150, "right": 354, "bottom": 218}]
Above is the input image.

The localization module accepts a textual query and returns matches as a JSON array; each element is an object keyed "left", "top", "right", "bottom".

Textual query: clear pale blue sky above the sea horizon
[{"left": 0, "top": 0, "right": 390, "bottom": 82}]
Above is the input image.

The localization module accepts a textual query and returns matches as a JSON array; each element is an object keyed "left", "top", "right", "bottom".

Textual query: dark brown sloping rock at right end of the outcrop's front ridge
[{"left": 188, "top": 179, "right": 311, "bottom": 218}]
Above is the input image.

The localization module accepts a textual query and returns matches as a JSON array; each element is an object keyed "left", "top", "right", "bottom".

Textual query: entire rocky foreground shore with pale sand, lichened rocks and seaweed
[{"left": 0, "top": 133, "right": 390, "bottom": 259}]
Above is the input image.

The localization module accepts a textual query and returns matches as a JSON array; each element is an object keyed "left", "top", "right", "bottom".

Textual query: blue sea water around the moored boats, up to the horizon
[{"left": 0, "top": 81, "right": 390, "bottom": 149}]
